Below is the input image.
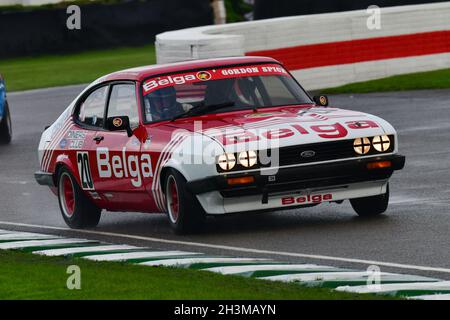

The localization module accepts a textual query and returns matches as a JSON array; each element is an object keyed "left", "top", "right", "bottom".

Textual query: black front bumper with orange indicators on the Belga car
[{"left": 187, "top": 155, "right": 405, "bottom": 203}]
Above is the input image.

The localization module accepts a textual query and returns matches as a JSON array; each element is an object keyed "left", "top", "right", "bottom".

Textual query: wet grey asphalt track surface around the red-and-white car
[{"left": 0, "top": 86, "right": 450, "bottom": 279}]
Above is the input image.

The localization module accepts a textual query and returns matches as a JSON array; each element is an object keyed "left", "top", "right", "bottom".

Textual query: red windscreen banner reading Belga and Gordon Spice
[{"left": 143, "top": 64, "right": 288, "bottom": 94}]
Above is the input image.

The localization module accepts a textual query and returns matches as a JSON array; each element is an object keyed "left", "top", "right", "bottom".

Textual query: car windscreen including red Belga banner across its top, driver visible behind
[{"left": 143, "top": 64, "right": 313, "bottom": 122}]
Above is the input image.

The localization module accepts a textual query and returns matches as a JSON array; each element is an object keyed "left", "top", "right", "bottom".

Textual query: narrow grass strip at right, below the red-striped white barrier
[{"left": 321, "top": 69, "right": 450, "bottom": 94}]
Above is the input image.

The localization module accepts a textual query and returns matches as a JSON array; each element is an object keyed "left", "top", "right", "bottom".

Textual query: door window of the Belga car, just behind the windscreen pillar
[{"left": 108, "top": 84, "right": 139, "bottom": 128}]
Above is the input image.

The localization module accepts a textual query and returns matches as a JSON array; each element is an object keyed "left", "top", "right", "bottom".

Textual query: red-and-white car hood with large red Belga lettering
[{"left": 163, "top": 107, "right": 395, "bottom": 151}]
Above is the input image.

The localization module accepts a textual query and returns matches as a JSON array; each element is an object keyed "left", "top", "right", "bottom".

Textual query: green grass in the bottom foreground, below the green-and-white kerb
[{"left": 0, "top": 251, "right": 386, "bottom": 300}]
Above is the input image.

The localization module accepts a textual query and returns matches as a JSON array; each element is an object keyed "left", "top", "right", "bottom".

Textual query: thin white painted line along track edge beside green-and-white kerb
[{"left": 0, "top": 221, "right": 450, "bottom": 274}]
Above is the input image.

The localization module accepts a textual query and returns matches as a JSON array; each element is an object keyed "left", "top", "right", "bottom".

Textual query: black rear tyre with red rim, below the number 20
[{"left": 58, "top": 168, "right": 101, "bottom": 229}]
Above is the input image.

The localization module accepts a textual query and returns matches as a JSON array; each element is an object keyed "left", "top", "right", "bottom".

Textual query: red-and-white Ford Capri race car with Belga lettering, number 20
[{"left": 35, "top": 57, "right": 405, "bottom": 233}]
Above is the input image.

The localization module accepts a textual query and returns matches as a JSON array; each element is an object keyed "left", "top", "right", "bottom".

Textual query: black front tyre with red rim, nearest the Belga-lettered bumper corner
[{"left": 164, "top": 169, "right": 206, "bottom": 234}]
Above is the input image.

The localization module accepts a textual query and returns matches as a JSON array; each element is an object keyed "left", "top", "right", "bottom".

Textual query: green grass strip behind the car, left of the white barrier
[{"left": 0, "top": 45, "right": 156, "bottom": 91}]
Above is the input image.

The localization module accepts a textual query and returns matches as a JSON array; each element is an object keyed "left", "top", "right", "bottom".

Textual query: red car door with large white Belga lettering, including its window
[{"left": 93, "top": 82, "right": 151, "bottom": 211}]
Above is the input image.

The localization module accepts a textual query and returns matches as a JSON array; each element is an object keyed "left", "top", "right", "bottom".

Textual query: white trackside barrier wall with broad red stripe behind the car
[{"left": 156, "top": 2, "right": 450, "bottom": 90}]
